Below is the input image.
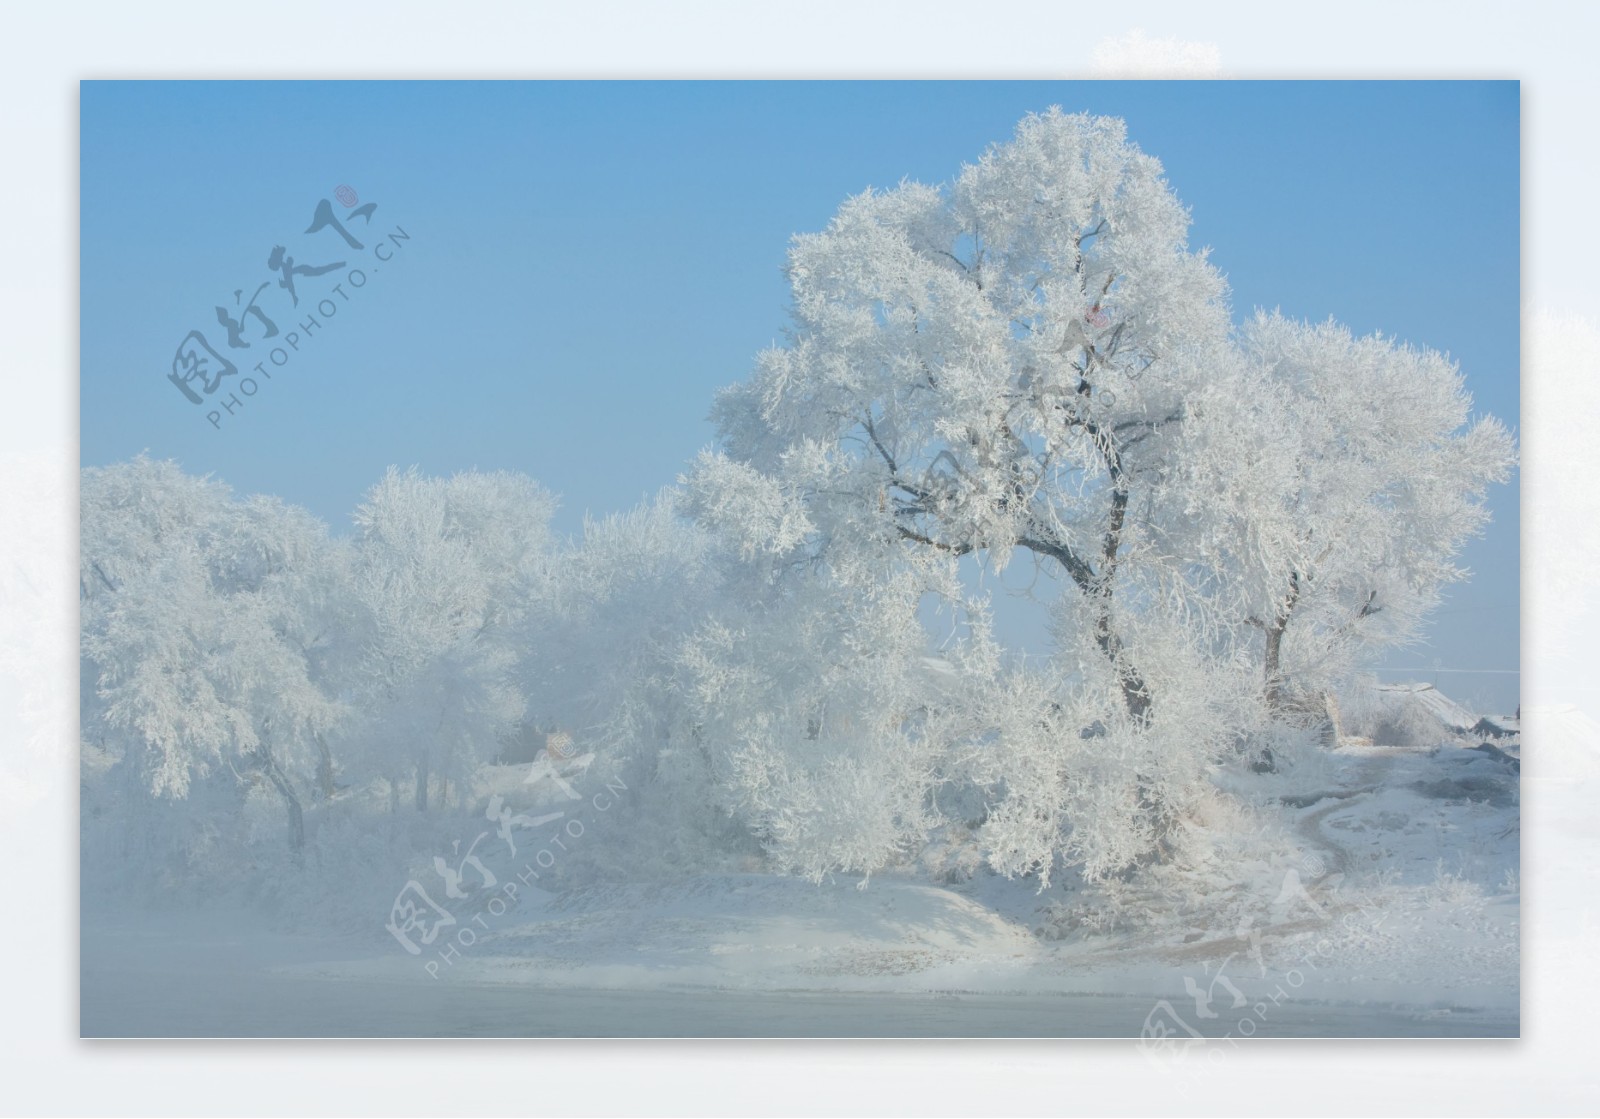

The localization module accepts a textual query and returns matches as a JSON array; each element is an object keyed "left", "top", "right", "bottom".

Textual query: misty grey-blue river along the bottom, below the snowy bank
[{"left": 80, "top": 928, "right": 1517, "bottom": 1044}]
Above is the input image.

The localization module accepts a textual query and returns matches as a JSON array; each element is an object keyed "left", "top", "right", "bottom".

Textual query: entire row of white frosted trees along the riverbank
[{"left": 80, "top": 110, "right": 1514, "bottom": 902}]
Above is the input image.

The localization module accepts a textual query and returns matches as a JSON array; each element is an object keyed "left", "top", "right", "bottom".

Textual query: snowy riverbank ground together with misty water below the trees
[{"left": 82, "top": 707, "right": 1520, "bottom": 1044}]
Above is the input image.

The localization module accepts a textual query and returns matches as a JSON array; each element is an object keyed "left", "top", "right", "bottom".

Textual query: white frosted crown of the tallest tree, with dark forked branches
[{"left": 691, "top": 110, "right": 1232, "bottom": 714}]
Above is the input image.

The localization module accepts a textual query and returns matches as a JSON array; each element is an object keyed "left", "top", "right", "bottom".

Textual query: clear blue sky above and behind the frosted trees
[{"left": 82, "top": 82, "right": 1520, "bottom": 708}]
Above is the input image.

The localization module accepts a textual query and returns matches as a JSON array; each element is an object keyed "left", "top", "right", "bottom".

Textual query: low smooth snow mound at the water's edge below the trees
[{"left": 308, "top": 874, "right": 1040, "bottom": 991}]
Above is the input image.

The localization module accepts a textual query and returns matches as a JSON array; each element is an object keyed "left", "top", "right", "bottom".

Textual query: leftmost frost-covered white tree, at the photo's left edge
[{"left": 80, "top": 456, "right": 341, "bottom": 852}]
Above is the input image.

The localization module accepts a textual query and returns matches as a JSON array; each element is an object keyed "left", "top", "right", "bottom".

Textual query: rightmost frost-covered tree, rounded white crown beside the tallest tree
[{"left": 1232, "top": 314, "right": 1514, "bottom": 708}]
